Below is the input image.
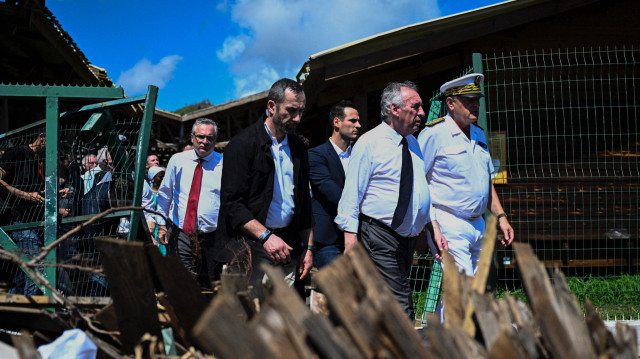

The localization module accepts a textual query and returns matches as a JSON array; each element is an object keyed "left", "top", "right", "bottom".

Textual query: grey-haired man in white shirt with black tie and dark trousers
[{"left": 335, "top": 81, "right": 430, "bottom": 320}]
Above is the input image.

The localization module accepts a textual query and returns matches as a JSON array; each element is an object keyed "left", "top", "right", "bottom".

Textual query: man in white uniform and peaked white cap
[{"left": 418, "top": 74, "right": 513, "bottom": 318}]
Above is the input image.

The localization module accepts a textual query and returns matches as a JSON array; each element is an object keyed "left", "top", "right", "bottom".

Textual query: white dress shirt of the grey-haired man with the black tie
[{"left": 335, "top": 122, "right": 431, "bottom": 237}]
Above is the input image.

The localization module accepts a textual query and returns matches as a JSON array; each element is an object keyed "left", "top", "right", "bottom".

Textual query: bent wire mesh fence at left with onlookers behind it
[{"left": 0, "top": 112, "right": 150, "bottom": 296}]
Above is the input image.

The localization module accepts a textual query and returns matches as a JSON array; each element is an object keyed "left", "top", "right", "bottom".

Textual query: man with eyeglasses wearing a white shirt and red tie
[{"left": 157, "top": 118, "right": 222, "bottom": 288}]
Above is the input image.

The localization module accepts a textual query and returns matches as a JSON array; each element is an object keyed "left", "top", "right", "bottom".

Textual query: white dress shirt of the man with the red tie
[{"left": 157, "top": 150, "right": 222, "bottom": 233}]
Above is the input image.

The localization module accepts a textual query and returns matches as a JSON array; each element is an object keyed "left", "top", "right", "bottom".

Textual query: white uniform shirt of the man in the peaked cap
[{"left": 418, "top": 115, "right": 493, "bottom": 219}]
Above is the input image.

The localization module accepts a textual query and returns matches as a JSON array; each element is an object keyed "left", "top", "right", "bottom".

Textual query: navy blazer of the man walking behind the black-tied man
[{"left": 309, "top": 140, "right": 345, "bottom": 246}]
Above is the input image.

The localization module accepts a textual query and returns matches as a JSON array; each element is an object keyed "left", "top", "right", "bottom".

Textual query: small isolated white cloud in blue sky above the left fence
[{"left": 116, "top": 55, "right": 182, "bottom": 95}]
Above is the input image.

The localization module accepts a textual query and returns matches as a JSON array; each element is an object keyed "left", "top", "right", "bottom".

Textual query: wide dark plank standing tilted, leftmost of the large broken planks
[{"left": 95, "top": 237, "right": 162, "bottom": 353}]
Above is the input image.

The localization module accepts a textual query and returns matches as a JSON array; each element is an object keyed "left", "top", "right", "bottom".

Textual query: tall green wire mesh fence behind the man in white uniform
[{"left": 482, "top": 47, "right": 640, "bottom": 319}]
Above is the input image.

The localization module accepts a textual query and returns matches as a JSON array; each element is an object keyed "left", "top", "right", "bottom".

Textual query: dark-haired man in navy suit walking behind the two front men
[{"left": 309, "top": 100, "right": 360, "bottom": 268}]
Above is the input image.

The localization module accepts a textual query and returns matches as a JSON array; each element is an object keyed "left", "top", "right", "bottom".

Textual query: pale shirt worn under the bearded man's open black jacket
[{"left": 264, "top": 122, "right": 295, "bottom": 228}]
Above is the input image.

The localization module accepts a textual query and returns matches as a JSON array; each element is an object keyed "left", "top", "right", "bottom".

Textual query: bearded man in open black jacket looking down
[{"left": 216, "top": 79, "right": 314, "bottom": 299}]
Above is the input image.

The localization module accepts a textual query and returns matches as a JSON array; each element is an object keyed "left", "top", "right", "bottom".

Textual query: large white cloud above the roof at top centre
[{"left": 218, "top": 0, "right": 440, "bottom": 96}]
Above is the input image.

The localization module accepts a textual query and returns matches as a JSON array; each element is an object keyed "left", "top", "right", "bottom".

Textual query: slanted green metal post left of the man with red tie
[{"left": 128, "top": 86, "right": 158, "bottom": 241}]
